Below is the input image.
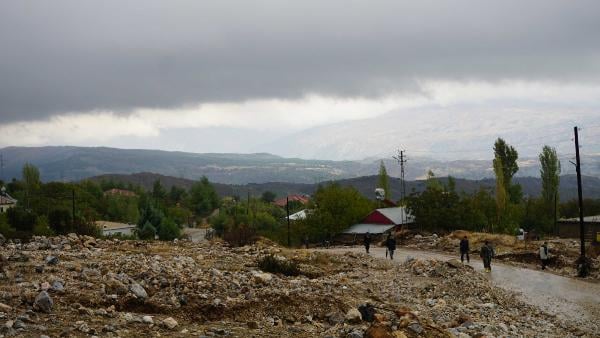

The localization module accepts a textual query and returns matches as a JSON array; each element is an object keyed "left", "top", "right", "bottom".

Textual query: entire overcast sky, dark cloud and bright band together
[{"left": 0, "top": 0, "right": 600, "bottom": 155}]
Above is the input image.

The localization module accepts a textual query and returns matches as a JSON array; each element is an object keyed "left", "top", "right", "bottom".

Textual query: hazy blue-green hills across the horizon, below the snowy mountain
[{"left": 0, "top": 146, "right": 600, "bottom": 185}]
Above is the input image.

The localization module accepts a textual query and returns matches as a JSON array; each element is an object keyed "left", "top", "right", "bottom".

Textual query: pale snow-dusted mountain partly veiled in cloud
[{"left": 260, "top": 105, "right": 600, "bottom": 161}]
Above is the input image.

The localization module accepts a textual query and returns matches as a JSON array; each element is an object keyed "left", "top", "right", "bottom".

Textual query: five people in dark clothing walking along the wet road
[{"left": 363, "top": 232, "right": 549, "bottom": 272}]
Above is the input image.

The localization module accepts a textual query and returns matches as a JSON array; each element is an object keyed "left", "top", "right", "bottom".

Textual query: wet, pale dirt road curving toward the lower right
[{"left": 324, "top": 247, "right": 600, "bottom": 328}]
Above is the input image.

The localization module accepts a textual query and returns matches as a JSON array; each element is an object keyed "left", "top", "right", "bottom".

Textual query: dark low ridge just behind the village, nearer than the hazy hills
[{"left": 90, "top": 173, "right": 600, "bottom": 201}]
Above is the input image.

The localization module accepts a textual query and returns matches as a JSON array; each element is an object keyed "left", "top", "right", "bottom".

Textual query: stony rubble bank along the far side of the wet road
[{"left": 400, "top": 230, "right": 600, "bottom": 282}]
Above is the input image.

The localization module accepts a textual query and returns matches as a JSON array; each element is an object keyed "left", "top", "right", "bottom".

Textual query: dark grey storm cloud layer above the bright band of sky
[{"left": 0, "top": 0, "right": 600, "bottom": 123}]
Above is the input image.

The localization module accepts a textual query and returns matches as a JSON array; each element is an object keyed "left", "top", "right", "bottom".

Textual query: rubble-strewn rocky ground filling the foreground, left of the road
[{"left": 0, "top": 235, "right": 600, "bottom": 338}]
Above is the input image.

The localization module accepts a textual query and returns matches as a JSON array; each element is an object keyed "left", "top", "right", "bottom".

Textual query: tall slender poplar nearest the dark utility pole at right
[{"left": 539, "top": 146, "right": 560, "bottom": 211}]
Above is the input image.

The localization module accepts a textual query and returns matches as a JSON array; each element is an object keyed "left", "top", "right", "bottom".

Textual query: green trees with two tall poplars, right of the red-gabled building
[{"left": 404, "top": 138, "right": 576, "bottom": 234}]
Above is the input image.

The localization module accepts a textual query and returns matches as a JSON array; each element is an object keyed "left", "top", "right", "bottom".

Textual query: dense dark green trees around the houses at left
[{"left": 0, "top": 164, "right": 221, "bottom": 240}]
